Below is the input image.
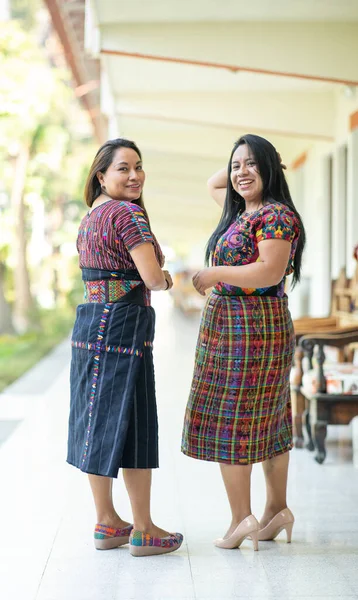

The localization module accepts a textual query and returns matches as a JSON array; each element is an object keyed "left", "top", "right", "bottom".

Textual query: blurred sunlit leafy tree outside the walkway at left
[{"left": 0, "top": 19, "right": 93, "bottom": 333}]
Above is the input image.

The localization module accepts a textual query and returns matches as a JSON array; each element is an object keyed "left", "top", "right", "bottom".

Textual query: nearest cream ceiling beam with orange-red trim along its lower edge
[{"left": 101, "top": 21, "right": 358, "bottom": 86}]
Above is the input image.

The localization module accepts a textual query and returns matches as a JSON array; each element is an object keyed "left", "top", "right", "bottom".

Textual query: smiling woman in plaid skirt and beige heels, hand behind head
[{"left": 182, "top": 135, "right": 305, "bottom": 550}]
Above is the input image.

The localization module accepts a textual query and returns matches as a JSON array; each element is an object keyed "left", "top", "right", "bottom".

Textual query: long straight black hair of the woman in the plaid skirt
[{"left": 205, "top": 134, "right": 306, "bottom": 286}]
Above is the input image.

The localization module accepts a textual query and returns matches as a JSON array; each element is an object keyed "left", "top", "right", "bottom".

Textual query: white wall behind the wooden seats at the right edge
[{"left": 290, "top": 87, "right": 358, "bottom": 317}]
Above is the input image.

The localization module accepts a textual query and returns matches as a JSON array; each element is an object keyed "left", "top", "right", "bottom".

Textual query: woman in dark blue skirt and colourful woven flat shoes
[{"left": 67, "top": 139, "right": 183, "bottom": 556}]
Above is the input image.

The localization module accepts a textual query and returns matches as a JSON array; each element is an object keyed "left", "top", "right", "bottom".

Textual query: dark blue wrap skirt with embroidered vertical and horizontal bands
[{"left": 67, "top": 270, "right": 158, "bottom": 477}]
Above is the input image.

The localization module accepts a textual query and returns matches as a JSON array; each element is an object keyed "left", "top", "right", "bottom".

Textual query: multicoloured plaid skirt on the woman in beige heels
[{"left": 182, "top": 292, "right": 295, "bottom": 465}]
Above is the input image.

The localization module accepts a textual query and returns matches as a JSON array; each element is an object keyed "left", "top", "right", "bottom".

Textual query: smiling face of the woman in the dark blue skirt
[{"left": 97, "top": 148, "right": 145, "bottom": 202}]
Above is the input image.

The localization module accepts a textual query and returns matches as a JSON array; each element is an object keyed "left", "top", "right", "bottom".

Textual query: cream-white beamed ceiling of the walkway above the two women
[{"left": 86, "top": 0, "right": 358, "bottom": 250}]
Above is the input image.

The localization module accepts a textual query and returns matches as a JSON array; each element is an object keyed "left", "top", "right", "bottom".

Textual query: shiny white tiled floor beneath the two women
[{"left": 0, "top": 294, "right": 358, "bottom": 600}]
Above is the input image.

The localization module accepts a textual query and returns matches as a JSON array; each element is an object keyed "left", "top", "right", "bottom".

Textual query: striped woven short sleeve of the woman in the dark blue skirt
[{"left": 114, "top": 202, "right": 154, "bottom": 252}]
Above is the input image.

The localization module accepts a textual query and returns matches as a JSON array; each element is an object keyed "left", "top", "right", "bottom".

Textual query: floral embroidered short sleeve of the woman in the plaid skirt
[{"left": 256, "top": 206, "right": 299, "bottom": 244}]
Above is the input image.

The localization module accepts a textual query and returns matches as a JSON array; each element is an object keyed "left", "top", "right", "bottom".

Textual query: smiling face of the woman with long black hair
[{"left": 231, "top": 144, "right": 263, "bottom": 205}]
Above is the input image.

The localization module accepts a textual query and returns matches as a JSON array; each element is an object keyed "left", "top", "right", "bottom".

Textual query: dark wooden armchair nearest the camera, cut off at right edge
[{"left": 299, "top": 329, "right": 358, "bottom": 464}]
